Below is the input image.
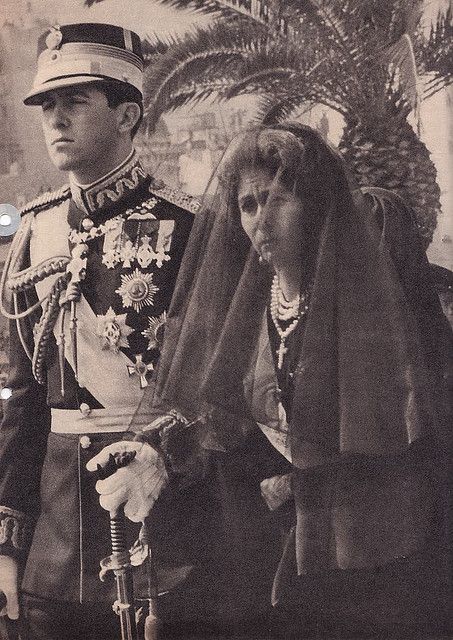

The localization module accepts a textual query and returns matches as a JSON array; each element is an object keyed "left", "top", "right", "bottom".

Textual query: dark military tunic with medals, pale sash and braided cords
[{"left": 0, "top": 153, "right": 198, "bottom": 600}]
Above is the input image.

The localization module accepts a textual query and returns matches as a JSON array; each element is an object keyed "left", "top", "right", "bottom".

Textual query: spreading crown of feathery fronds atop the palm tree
[{"left": 86, "top": 0, "right": 453, "bottom": 131}]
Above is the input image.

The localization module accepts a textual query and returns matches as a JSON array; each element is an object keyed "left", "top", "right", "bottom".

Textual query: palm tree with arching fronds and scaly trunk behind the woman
[{"left": 87, "top": 0, "right": 453, "bottom": 246}]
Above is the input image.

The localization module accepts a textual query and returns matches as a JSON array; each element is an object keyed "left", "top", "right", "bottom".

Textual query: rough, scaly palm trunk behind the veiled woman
[{"left": 339, "top": 113, "right": 441, "bottom": 249}]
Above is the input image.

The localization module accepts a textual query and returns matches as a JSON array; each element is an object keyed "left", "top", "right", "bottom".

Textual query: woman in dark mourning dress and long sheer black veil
[{"left": 131, "top": 123, "right": 452, "bottom": 638}]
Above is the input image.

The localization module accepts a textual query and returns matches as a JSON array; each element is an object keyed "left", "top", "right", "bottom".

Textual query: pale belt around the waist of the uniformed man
[{"left": 50, "top": 407, "right": 156, "bottom": 434}]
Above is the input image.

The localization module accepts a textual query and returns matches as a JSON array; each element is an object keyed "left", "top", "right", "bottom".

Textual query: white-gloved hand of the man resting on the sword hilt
[{"left": 87, "top": 440, "right": 168, "bottom": 522}]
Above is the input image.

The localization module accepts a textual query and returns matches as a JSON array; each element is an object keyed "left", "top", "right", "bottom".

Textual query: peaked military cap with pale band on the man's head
[{"left": 24, "top": 23, "right": 143, "bottom": 105}]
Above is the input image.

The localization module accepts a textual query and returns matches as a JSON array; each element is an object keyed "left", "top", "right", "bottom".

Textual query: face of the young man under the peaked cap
[{"left": 42, "top": 84, "right": 120, "bottom": 181}]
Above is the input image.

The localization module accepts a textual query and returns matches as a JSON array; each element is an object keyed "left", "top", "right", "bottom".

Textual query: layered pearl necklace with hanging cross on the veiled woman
[{"left": 270, "top": 275, "right": 308, "bottom": 369}]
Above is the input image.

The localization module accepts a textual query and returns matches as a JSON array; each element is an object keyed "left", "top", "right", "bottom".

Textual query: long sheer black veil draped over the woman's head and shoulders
[{"left": 132, "top": 123, "right": 451, "bottom": 468}]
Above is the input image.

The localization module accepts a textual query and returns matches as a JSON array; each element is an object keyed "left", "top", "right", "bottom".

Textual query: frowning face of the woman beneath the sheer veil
[{"left": 238, "top": 167, "right": 304, "bottom": 268}]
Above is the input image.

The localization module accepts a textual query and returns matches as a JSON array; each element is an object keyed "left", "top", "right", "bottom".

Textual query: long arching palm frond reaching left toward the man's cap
[{"left": 145, "top": 14, "right": 363, "bottom": 125}]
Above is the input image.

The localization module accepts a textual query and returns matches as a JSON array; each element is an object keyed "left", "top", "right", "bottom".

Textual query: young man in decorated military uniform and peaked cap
[{"left": 0, "top": 24, "right": 197, "bottom": 640}]
